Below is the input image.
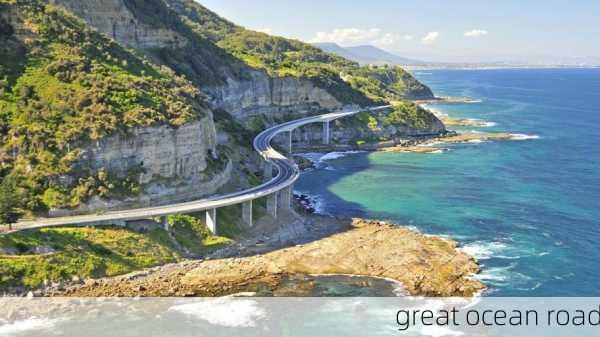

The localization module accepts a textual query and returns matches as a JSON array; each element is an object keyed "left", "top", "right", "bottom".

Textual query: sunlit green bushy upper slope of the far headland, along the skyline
[{"left": 164, "top": 0, "right": 433, "bottom": 103}]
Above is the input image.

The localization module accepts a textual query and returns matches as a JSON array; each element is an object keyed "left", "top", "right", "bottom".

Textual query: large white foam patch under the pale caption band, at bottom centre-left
[{"left": 169, "top": 296, "right": 266, "bottom": 327}]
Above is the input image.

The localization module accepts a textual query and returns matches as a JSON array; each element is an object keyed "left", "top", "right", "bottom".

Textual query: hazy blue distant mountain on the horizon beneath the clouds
[{"left": 314, "top": 43, "right": 426, "bottom": 66}]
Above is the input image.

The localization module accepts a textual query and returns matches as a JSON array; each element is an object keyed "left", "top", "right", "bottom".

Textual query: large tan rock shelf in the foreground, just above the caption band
[{"left": 44, "top": 216, "right": 485, "bottom": 297}]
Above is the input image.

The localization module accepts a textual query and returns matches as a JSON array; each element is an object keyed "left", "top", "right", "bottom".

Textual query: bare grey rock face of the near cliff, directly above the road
[{"left": 50, "top": 116, "right": 231, "bottom": 215}]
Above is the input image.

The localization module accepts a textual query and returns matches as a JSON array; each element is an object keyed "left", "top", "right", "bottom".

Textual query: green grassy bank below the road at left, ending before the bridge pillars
[{"left": 0, "top": 228, "right": 180, "bottom": 291}]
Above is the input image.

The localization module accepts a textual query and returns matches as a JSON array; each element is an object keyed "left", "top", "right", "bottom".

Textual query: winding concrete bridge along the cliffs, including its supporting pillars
[{"left": 8, "top": 105, "right": 390, "bottom": 234}]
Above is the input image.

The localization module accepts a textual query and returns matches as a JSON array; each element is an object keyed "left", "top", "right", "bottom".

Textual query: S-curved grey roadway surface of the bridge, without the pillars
[{"left": 5, "top": 105, "right": 390, "bottom": 233}]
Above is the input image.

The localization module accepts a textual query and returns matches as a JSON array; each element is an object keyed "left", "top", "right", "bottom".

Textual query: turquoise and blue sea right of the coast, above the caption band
[{"left": 296, "top": 69, "right": 600, "bottom": 296}]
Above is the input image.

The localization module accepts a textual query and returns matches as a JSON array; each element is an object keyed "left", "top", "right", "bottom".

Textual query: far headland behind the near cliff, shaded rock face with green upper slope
[{"left": 54, "top": 0, "right": 440, "bottom": 139}]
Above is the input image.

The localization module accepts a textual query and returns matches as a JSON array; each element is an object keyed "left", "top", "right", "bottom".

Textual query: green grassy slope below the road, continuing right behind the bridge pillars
[{"left": 0, "top": 210, "right": 251, "bottom": 293}]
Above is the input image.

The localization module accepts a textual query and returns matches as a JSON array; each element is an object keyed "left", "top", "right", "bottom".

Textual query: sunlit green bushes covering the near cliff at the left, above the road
[{"left": 0, "top": 0, "right": 207, "bottom": 211}]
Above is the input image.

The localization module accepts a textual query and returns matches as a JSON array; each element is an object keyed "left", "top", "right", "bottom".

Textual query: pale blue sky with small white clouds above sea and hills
[{"left": 199, "top": 0, "right": 600, "bottom": 63}]
